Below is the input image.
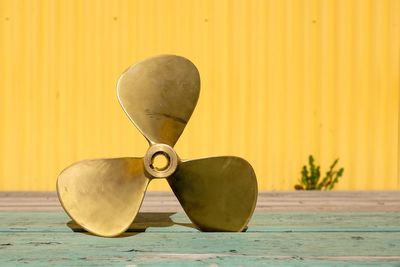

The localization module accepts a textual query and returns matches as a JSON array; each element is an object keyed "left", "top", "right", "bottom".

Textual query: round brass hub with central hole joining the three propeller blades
[{"left": 143, "top": 144, "right": 179, "bottom": 178}]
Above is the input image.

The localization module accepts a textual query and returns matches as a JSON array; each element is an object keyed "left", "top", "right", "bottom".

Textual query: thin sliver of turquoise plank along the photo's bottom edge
[{"left": 2, "top": 255, "right": 399, "bottom": 267}]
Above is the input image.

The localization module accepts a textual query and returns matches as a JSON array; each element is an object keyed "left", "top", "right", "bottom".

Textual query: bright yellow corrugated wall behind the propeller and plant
[{"left": 0, "top": 0, "right": 400, "bottom": 191}]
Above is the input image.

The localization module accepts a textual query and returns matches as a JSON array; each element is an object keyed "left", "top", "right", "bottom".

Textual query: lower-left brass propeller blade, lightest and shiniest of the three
[{"left": 57, "top": 158, "right": 150, "bottom": 237}]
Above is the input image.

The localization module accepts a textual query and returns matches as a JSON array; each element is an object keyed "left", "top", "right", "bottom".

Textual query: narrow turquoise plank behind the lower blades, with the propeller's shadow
[{"left": 0, "top": 212, "right": 400, "bottom": 232}]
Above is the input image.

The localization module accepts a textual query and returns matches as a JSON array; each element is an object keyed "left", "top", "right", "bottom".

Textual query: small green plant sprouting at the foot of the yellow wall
[{"left": 294, "top": 155, "right": 344, "bottom": 190}]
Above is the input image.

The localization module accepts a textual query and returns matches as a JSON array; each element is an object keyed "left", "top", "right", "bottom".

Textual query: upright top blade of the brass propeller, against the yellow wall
[{"left": 117, "top": 55, "right": 200, "bottom": 147}]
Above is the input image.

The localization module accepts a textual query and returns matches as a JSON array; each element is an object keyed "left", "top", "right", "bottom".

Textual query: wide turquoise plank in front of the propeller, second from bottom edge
[{"left": 0, "top": 232, "right": 400, "bottom": 266}]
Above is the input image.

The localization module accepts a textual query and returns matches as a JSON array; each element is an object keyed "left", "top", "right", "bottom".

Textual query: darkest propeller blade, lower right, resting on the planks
[{"left": 168, "top": 157, "right": 257, "bottom": 231}]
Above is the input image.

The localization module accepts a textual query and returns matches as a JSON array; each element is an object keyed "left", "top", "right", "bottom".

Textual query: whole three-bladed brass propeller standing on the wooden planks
[{"left": 57, "top": 55, "right": 257, "bottom": 237}]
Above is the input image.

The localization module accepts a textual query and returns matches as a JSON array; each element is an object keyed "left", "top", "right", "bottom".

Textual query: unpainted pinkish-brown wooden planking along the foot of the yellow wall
[{"left": 0, "top": 191, "right": 400, "bottom": 211}]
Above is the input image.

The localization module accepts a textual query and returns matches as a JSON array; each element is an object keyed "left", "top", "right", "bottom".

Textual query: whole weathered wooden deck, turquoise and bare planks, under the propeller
[{"left": 0, "top": 192, "right": 400, "bottom": 266}]
